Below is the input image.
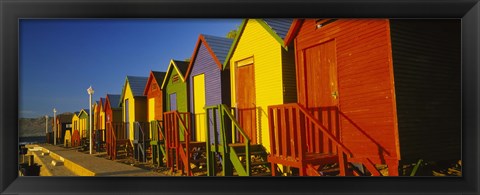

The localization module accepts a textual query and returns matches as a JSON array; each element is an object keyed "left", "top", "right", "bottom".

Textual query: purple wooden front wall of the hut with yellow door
[{"left": 188, "top": 43, "right": 226, "bottom": 142}]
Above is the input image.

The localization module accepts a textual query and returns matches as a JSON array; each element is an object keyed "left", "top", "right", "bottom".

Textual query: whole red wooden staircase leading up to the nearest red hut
[{"left": 268, "top": 103, "right": 381, "bottom": 176}]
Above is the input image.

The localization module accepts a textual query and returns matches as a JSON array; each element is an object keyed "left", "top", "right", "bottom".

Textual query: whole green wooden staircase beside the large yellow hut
[{"left": 206, "top": 104, "right": 271, "bottom": 176}]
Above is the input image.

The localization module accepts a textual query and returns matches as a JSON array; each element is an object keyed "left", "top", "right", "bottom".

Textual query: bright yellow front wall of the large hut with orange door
[{"left": 230, "top": 19, "right": 284, "bottom": 150}]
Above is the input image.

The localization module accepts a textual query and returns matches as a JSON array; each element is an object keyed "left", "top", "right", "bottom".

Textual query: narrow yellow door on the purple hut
[{"left": 193, "top": 74, "right": 206, "bottom": 142}]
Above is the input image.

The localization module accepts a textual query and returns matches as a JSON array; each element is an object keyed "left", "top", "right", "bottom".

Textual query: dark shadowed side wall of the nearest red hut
[{"left": 390, "top": 19, "right": 461, "bottom": 162}]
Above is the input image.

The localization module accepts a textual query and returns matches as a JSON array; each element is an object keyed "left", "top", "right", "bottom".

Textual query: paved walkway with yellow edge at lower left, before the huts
[{"left": 30, "top": 144, "right": 165, "bottom": 176}]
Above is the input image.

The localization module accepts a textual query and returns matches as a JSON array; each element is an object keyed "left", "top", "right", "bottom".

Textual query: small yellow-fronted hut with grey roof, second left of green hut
[{"left": 118, "top": 76, "right": 149, "bottom": 161}]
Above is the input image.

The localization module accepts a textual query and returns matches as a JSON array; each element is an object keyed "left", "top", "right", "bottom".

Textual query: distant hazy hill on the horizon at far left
[{"left": 18, "top": 112, "right": 72, "bottom": 137}]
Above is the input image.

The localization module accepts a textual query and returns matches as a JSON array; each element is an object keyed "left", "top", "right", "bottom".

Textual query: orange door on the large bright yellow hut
[{"left": 235, "top": 63, "right": 257, "bottom": 144}]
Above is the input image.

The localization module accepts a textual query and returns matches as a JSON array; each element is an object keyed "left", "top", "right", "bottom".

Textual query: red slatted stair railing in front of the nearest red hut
[{"left": 268, "top": 103, "right": 352, "bottom": 175}]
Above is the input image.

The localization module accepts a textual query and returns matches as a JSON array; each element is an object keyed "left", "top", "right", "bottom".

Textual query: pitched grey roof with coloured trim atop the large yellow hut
[{"left": 223, "top": 18, "right": 293, "bottom": 67}]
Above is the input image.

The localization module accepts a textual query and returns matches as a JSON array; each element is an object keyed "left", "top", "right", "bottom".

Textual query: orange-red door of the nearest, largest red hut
[{"left": 304, "top": 40, "right": 339, "bottom": 153}]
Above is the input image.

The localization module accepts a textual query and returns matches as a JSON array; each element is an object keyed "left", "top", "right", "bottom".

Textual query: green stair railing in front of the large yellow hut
[{"left": 205, "top": 104, "right": 251, "bottom": 176}]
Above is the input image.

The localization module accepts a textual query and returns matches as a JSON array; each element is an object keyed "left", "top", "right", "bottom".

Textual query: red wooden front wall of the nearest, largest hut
[{"left": 295, "top": 19, "right": 398, "bottom": 163}]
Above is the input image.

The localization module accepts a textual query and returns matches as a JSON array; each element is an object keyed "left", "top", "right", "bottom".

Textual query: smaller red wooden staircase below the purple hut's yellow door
[{"left": 164, "top": 111, "right": 207, "bottom": 176}]
